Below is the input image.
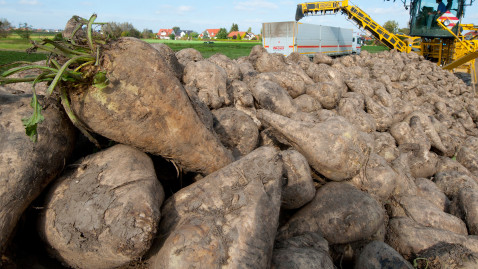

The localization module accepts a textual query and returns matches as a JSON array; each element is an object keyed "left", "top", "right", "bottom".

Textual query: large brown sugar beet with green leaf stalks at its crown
[{"left": 70, "top": 38, "right": 232, "bottom": 174}]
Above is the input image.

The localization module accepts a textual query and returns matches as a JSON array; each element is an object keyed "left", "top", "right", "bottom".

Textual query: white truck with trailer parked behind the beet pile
[{"left": 262, "top": 21, "right": 361, "bottom": 57}]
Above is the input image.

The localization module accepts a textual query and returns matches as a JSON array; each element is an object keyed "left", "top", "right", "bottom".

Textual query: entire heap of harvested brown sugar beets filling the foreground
[{"left": 0, "top": 29, "right": 478, "bottom": 268}]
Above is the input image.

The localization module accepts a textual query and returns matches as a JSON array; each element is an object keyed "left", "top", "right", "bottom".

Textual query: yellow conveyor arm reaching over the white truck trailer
[{"left": 295, "top": 0, "right": 412, "bottom": 52}]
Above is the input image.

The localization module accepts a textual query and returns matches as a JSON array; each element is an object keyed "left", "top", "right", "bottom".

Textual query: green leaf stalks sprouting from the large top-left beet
[{"left": 0, "top": 14, "right": 108, "bottom": 147}]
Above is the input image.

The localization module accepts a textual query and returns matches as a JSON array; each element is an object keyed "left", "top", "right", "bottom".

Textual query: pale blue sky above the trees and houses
[{"left": 0, "top": 0, "right": 478, "bottom": 33}]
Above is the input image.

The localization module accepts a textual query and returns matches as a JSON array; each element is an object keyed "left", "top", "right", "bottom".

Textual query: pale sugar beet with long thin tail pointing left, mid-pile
[{"left": 257, "top": 110, "right": 370, "bottom": 181}]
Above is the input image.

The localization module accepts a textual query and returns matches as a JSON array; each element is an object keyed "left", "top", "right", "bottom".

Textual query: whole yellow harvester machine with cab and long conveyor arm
[{"left": 295, "top": 0, "right": 478, "bottom": 83}]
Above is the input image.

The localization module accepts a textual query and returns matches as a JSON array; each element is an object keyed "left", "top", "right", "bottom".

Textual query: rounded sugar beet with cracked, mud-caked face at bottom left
[{"left": 39, "top": 145, "right": 164, "bottom": 268}]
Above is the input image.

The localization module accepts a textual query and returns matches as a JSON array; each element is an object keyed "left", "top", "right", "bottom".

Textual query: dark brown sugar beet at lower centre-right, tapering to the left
[{"left": 278, "top": 182, "right": 385, "bottom": 244}]
